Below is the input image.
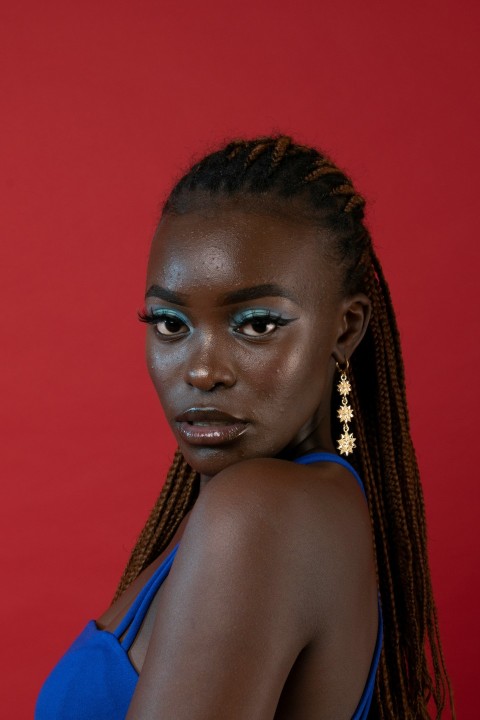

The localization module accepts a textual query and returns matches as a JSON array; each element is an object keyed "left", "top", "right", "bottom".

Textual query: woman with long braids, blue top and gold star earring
[{"left": 37, "top": 137, "right": 452, "bottom": 720}]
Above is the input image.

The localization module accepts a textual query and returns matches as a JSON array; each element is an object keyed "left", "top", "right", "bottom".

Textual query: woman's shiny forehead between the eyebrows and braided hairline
[{"left": 147, "top": 203, "right": 339, "bottom": 302}]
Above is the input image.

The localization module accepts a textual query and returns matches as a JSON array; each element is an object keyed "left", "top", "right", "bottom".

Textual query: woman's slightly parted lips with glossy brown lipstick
[{"left": 175, "top": 408, "right": 248, "bottom": 445}]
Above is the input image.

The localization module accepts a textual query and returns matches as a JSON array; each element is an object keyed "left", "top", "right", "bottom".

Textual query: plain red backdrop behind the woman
[{"left": 0, "top": 0, "right": 480, "bottom": 718}]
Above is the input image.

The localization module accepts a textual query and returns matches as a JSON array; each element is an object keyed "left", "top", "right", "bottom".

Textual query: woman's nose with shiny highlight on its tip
[{"left": 185, "top": 336, "right": 236, "bottom": 392}]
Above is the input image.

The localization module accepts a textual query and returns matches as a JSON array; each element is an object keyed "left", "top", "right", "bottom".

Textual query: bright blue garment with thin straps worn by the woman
[{"left": 35, "top": 452, "right": 383, "bottom": 720}]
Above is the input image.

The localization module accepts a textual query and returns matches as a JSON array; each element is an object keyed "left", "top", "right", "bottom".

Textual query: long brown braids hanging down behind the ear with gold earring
[{"left": 352, "top": 253, "right": 455, "bottom": 718}]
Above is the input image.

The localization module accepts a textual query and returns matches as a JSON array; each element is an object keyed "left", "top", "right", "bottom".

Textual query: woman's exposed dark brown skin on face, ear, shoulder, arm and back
[{"left": 98, "top": 200, "right": 378, "bottom": 720}]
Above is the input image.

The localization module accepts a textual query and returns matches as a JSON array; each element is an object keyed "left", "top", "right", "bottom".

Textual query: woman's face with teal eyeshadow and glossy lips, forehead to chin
[{"left": 145, "top": 201, "right": 343, "bottom": 477}]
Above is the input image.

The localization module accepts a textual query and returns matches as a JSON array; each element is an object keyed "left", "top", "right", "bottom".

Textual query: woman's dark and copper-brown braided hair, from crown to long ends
[{"left": 115, "top": 136, "right": 455, "bottom": 720}]
